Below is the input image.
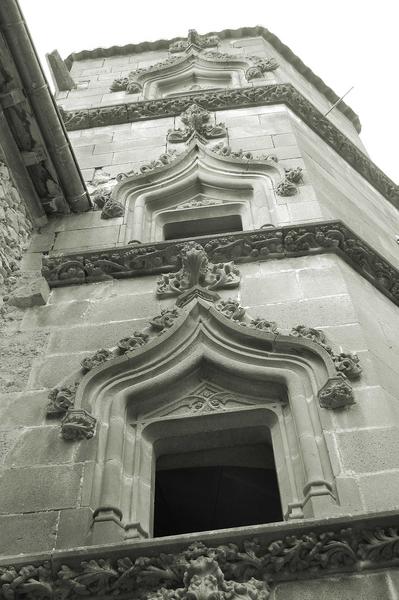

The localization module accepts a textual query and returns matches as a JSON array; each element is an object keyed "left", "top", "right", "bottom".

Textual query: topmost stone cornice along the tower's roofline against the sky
[{"left": 65, "top": 25, "right": 361, "bottom": 132}]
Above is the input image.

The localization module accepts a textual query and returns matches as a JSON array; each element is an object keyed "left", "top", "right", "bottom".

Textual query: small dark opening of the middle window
[{"left": 163, "top": 215, "right": 242, "bottom": 240}]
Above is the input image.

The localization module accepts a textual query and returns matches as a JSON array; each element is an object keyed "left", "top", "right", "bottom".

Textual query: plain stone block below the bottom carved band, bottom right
[{"left": 273, "top": 573, "right": 394, "bottom": 600}]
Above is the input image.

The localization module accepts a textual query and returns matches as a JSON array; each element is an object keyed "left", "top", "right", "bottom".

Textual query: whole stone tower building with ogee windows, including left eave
[{"left": 0, "top": 0, "right": 399, "bottom": 600}]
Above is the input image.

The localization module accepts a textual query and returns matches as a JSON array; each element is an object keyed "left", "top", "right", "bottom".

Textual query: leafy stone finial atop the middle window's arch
[{"left": 167, "top": 104, "right": 226, "bottom": 144}]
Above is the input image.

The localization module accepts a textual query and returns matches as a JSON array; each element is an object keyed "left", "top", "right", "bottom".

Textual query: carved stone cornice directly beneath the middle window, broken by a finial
[{"left": 42, "top": 221, "right": 399, "bottom": 305}]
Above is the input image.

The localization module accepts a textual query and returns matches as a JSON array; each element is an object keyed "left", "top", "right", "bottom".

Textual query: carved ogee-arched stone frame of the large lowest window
[{"left": 76, "top": 299, "right": 340, "bottom": 543}]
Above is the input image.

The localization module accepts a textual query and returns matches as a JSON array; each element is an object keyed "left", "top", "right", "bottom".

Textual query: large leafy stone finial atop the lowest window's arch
[{"left": 157, "top": 242, "right": 240, "bottom": 305}]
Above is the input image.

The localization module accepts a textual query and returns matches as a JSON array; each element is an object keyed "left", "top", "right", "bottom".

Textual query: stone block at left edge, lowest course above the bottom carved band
[{"left": 0, "top": 510, "right": 58, "bottom": 556}]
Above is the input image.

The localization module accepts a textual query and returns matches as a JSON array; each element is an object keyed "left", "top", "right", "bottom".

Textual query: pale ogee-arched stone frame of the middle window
[{"left": 112, "top": 141, "right": 284, "bottom": 243}]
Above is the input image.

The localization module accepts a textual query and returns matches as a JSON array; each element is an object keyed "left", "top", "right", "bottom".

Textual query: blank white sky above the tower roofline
[{"left": 19, "top": 0, "right": 399, "bottom": 183}]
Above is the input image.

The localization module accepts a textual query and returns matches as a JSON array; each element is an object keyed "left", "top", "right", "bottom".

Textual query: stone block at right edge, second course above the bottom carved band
[{"left": 335, "top": 427, "right": 399, "bottom": 479}]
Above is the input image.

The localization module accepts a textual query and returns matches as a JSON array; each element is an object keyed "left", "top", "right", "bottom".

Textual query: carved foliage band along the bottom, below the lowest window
[{"left": 0, "top": 527, "right": 399, "bottom": 600}]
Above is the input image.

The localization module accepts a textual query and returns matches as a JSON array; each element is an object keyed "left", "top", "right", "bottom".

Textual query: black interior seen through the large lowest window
[{"left": 154, "top": 444, "right": 283, "bottom": 537}]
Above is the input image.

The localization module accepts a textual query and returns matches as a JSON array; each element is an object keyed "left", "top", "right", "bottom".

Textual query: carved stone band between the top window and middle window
[{"left": 62, "top": 83, "right": 399, "bottom": 208}]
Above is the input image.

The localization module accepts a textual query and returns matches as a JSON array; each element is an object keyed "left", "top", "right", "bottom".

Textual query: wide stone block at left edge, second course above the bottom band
[{"left": 0, "top": 465, "right": 82, "bottom": 514}]
